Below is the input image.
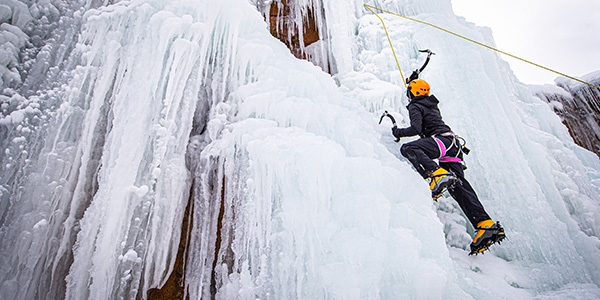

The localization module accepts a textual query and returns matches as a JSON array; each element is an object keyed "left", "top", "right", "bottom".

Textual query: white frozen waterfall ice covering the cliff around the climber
[{"left": 0, "top": 0, "right": 600, "bottom": 299}]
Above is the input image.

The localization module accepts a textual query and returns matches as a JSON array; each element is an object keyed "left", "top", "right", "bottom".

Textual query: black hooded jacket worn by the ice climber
[{"left": 392, "top": 95, "right": 451, "bottom": 138}]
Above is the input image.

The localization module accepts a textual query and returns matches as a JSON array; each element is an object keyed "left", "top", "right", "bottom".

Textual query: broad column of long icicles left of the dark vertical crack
[{"left": 0, "top": 1, "right": 206, "bottom": 299}]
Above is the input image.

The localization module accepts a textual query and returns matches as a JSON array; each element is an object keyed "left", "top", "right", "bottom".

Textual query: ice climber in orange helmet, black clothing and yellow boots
[{"left": 392, "top": 76, "right": 505, "bottom": 254}]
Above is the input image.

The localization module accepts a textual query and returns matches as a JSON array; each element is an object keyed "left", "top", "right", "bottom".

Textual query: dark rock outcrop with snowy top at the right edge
[{"left": 536, "top": 72, "right": 600, "bottom": 156}]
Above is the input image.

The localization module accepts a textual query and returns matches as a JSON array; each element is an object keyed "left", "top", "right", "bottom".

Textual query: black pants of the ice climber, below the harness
[{"left": 400, "top": 136, "right": 491, "bottom": 227}]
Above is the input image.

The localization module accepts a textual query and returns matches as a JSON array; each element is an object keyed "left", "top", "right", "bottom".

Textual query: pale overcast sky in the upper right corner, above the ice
[{"left": 451, "top": 0, "right": 600, "bottom": 84}]
